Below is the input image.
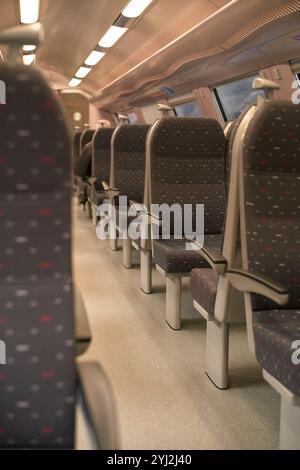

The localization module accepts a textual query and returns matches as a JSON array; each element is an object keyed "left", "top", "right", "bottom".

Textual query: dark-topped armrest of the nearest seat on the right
[{"left": 226, "top": 269, "right": 289, "bottom": 305}]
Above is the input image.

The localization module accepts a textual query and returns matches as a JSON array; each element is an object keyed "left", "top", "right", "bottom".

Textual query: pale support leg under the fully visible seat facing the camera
[{"left": 166, "top": 276, "right": 181, "bottom": 330}]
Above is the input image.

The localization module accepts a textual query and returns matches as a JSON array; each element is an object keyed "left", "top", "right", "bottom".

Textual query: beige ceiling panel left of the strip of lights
[{"left": 38, "top": 0, "right": 128, "bottom": 81}]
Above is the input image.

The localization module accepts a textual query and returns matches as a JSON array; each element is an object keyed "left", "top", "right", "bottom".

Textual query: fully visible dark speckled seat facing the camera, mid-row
[{"left": 149, "top": 118, "right": 226, "bottom": 329}]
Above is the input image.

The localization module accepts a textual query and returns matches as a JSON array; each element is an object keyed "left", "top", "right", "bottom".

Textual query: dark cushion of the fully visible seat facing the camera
[{"left": 153, "top": 234, "right": 222, "bottom": 274}]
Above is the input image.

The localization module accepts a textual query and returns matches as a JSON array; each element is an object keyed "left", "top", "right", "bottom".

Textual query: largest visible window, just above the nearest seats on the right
[{"left": 214, "top": 75, "right": 265, "bottom": 121}]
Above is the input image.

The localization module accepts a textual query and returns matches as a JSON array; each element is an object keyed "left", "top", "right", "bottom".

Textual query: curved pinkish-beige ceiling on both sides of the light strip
[{"left": 0, "top": 0, "right": 300, "bottom": 107}]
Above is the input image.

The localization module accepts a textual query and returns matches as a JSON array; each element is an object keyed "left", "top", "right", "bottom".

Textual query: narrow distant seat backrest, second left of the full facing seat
[{"left": 92, "top": 127, "right": 115, "bottom": 188}]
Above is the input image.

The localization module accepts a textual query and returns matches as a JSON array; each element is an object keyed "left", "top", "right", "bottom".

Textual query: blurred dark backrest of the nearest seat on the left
[{"left": 0, "top": 65, "right": 75, "bottom": 448}]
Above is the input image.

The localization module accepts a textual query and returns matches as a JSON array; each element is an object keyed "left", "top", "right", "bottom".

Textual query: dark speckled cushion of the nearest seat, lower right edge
[{"left": 254, "top": 309, "right": 300, "bottom": 397}]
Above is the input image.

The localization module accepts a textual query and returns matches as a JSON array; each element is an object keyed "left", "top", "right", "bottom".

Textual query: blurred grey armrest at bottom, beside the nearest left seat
[{"left": 77, "top": 362, "right": 119, "bottom": 450}]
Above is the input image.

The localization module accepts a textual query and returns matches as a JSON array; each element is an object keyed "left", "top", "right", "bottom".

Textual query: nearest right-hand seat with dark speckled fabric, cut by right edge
[{"left": 220, "top": 98, "right": 300, "bottom": 450}]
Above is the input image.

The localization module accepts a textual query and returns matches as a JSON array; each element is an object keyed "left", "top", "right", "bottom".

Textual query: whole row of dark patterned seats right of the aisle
[{"left": 73, "top": 79, "right": 300, "bottom": 448}]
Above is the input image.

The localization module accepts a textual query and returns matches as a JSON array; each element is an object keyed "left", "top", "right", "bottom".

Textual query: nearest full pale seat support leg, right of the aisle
[{"left": 206, "top": 320, "right": 229, "bottom": 390}]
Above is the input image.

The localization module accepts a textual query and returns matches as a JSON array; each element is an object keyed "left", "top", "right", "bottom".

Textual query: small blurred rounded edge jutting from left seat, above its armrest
[{"left": 74, "top": 287, "right": 92, "bottom": 356}]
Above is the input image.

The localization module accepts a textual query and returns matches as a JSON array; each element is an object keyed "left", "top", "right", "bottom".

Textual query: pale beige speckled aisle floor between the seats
[{"left": 74, "top": 207, "right": 279, "bottom": 450}]
